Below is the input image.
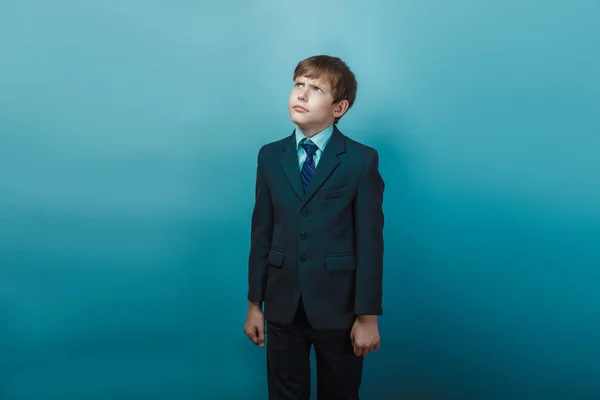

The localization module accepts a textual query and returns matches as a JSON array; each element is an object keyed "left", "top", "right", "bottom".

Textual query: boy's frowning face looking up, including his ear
[{"left": 288, "top": 76, "right": 347, "bottom": 136}]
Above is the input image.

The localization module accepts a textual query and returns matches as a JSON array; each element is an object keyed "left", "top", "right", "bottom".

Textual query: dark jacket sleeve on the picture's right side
[{"left": 354, "top": 150, "right": 385, "bottom": 315}]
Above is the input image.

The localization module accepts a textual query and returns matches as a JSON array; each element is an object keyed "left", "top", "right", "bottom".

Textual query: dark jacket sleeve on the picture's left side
[{"left": 248, "top": 147, "right": 273, "bottom": 302}]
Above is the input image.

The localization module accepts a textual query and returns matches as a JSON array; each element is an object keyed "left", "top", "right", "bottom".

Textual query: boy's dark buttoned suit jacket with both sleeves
[{"left": 248, "top": 127, "right": 384, "bottom": 329}]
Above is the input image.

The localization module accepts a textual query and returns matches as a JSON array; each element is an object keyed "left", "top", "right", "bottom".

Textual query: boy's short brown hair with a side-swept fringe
[{"left": 294, "top": 55, "right": 358, "bottom": 124}]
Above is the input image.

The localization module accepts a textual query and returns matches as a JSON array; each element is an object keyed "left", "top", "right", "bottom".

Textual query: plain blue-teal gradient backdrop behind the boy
[{"left": 0, "top": 0, "right": 600, "bottom": 400}]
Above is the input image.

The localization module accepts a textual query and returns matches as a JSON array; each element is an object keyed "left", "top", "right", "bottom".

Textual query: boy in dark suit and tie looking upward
[{"left": 244, "top": 56, "right": 384, "bottom": 400}]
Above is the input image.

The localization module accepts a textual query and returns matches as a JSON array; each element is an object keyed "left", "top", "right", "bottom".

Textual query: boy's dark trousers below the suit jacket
[{"left": 267, "top": 301, "right": 363, "bottom": 400}]
